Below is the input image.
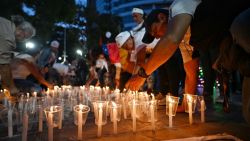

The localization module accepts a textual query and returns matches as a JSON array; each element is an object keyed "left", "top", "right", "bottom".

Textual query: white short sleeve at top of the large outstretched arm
[{"left": 169, "top": 0, "right": 201, "bottom": 19}]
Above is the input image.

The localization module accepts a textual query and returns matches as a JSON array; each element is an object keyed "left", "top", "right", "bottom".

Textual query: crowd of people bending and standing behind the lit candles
[{"left": 0, "top": 0, "right": 250, "bottom": 122}]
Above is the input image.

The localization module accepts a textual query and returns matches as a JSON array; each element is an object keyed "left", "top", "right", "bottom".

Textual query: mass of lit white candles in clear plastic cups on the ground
[{"left": 0, "top": 86, "right": 205, "bottom": 141}]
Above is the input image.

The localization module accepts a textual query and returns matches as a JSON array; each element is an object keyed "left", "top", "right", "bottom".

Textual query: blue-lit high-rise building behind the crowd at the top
[{"left": 96, "top": 0, "right": 173, "bottom": 30}]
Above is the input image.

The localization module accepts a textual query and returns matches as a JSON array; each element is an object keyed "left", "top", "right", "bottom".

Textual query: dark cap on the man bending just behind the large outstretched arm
[{"left": 144, "top": 9, "right": 169, "bottom": 31}]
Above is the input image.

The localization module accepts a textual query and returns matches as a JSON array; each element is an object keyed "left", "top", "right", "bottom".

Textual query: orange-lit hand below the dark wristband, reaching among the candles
[{"left": 126, "top": 75, "right": 146, "bottom": 91}]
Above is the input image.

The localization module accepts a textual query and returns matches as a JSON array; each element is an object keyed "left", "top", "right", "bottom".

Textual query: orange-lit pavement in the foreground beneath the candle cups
[{"left": 0, "top": 94, "right": 250, "bottom": 141}]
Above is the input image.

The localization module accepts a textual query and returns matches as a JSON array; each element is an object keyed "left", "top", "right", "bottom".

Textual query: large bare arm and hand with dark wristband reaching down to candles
[{"left": 126, "top": 14, "right": 192, "bottom": 90}]
